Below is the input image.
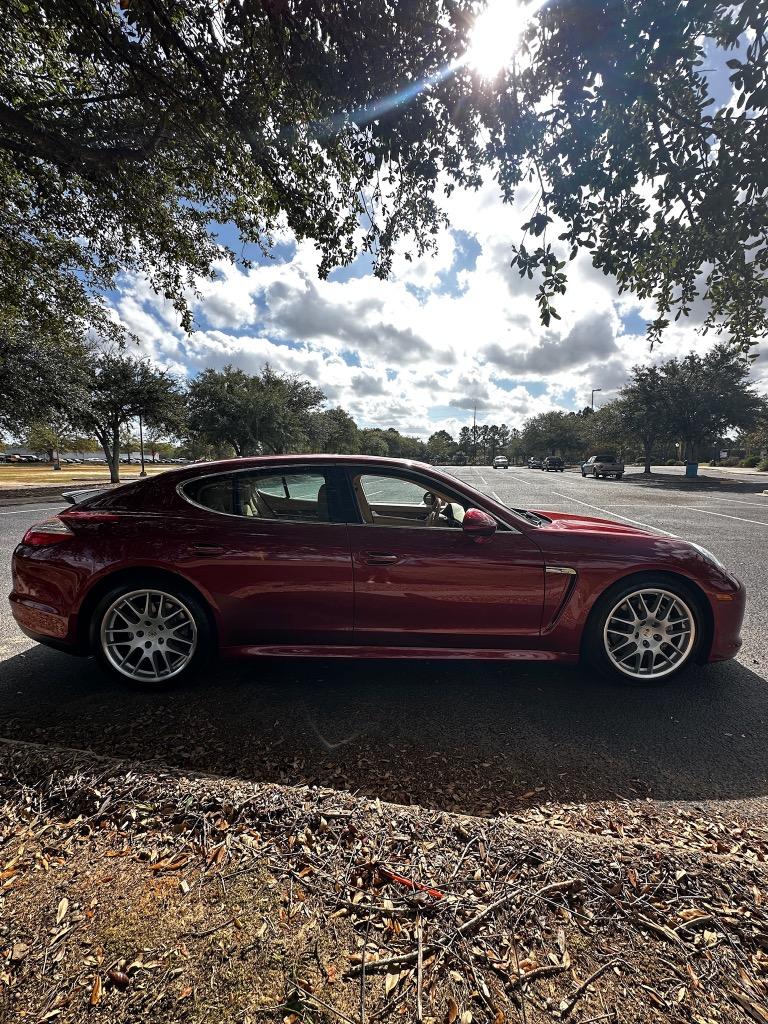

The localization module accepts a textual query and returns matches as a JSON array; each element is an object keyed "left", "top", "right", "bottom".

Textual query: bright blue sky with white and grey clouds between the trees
[{"left": 110, "top": 27, "right": 768, "bottom": 438}]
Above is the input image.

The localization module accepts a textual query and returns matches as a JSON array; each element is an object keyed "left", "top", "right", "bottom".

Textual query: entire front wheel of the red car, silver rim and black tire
[{"left": 583, "top": 575, "right": 705, "bottom": 683}]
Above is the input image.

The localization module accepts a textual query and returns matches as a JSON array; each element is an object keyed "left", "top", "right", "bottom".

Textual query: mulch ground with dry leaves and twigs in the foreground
[{"left": 0, "top": 743, "right": 768, "bottom": 1024}]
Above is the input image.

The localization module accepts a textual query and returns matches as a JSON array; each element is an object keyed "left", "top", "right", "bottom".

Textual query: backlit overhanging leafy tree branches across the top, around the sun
[{"left": 0, "top": 0, "right": 768, "bottom": 346}]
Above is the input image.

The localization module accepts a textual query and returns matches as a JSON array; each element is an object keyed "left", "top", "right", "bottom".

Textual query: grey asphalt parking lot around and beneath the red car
[{"left": 0, "top": 467, "right": 768, "bottom": 814}]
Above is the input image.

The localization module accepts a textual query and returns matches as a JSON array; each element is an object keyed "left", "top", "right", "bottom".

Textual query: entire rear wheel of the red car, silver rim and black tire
[{"left": 91, "top": 581, "right": 213, "bottom": 689}]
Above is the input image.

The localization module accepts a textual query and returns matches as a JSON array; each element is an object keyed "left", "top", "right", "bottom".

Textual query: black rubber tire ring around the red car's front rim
[{"left": 582, "top": 572, "right": 708, "bottom": 686}]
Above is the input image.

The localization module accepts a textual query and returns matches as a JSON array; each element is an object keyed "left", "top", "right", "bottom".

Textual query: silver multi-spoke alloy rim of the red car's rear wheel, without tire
[{"left": 100, "top": 590, "right": 198, "bottom": 683}]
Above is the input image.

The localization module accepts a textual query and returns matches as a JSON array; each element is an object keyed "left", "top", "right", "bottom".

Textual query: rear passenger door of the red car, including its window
[{"left": 167, "top": 464, "right": 353, "bottom": 646}]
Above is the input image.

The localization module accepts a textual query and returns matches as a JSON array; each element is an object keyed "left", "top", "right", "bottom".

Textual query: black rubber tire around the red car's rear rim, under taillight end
[{"left": 90, "top": 574, "right": 216, "bottom": 692}]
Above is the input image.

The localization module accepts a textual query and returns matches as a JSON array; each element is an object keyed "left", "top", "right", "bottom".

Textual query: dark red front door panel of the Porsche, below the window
[{"left": 349, "top": 524, "right": 544, "bottom": 647}]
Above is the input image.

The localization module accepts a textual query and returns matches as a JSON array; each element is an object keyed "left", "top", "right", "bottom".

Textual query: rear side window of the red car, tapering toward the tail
[{"left": 182, "top": 470, "right": 331, "bottom": 522}]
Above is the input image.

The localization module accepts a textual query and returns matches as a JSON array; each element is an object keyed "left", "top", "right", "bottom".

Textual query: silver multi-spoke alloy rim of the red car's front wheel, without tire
[{"left": 603, "top": 587, "right": 696, "bottom": 679}]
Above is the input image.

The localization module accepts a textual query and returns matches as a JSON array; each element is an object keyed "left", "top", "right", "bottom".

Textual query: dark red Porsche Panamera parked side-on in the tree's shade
[{"left": 10, "top": 456, "right": 744, "bottom": 686}]
